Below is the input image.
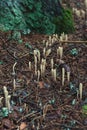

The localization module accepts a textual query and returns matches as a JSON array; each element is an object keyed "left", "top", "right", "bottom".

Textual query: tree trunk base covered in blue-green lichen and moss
[{"left": 0, "top": 0, "right": 74, "bottom": 34}]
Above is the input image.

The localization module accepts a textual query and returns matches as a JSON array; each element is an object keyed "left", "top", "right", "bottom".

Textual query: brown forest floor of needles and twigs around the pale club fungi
[{"left": 0, "top": 0, "right": 87, "bottom": 130}]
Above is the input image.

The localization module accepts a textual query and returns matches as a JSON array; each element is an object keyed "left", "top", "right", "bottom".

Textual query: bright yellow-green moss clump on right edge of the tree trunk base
[{"left": 53, "top": 9, "right": 74, "bottom": 34}]
